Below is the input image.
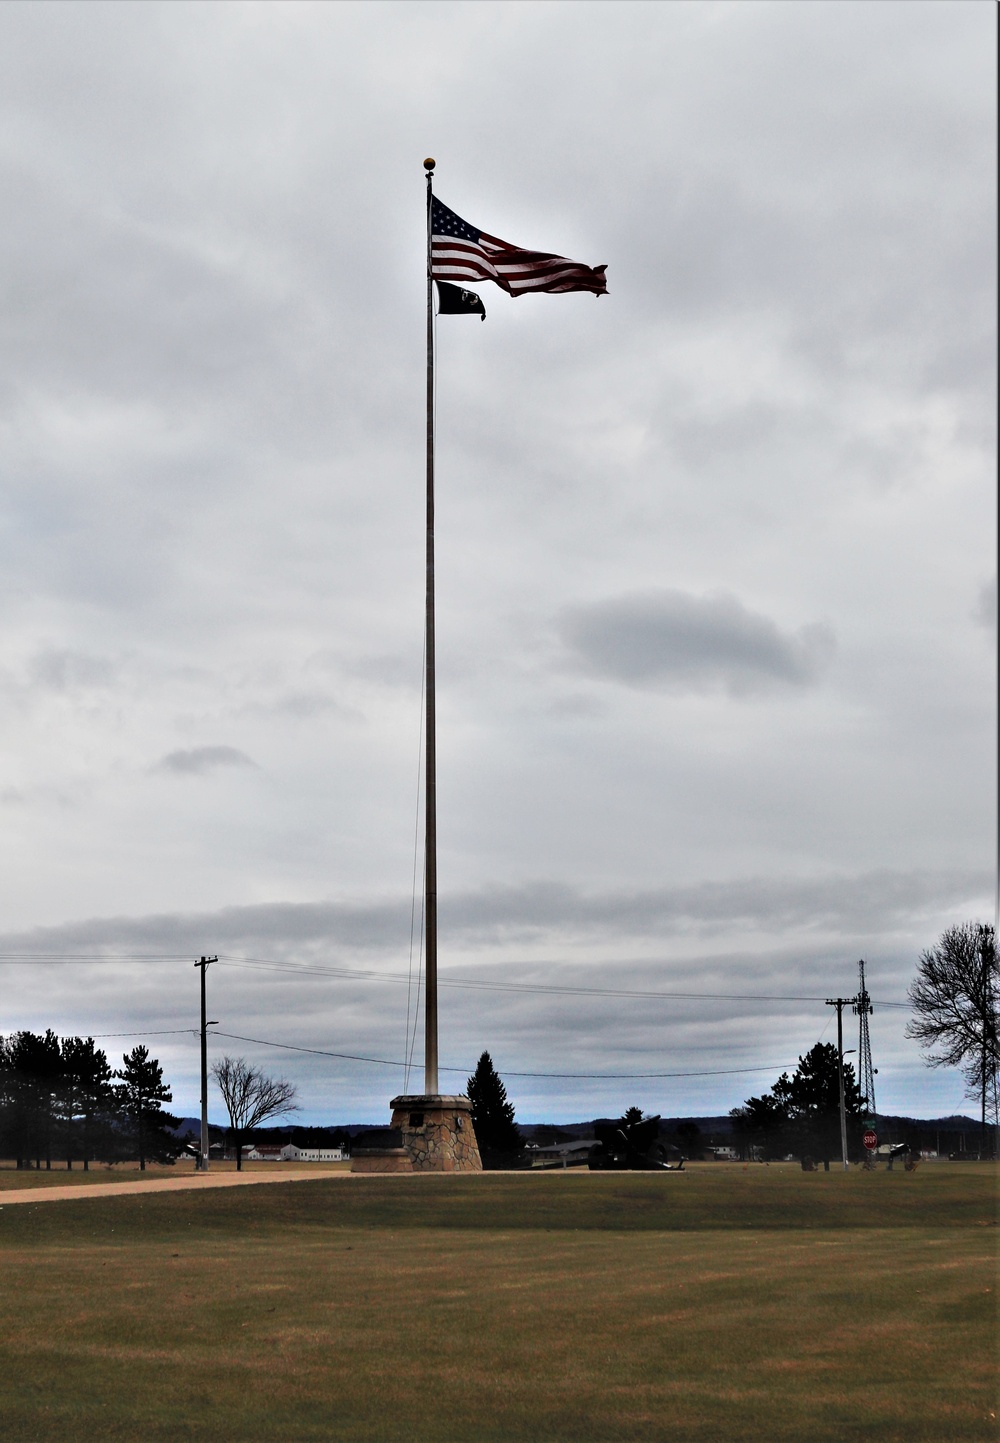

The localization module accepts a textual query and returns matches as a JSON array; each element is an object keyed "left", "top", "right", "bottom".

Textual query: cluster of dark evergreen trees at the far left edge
[{"left": 0, "top": 1027, "right": 179, "bottom": 1170}]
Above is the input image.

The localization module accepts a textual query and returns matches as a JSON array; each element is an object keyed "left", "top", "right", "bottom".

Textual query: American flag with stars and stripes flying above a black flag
[{"left": 430, "top": 196, "right": 608, "bottom": 296}]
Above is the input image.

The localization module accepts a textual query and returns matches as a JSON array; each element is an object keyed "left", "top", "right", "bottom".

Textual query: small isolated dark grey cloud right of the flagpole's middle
[{"left": 560, "top": 590, "right": 834, "bottom": 696}]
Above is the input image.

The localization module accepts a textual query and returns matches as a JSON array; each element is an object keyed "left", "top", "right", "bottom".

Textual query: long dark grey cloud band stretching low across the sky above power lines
[{"left": 0, "top": 869, "right": 990, "bottom": 957}]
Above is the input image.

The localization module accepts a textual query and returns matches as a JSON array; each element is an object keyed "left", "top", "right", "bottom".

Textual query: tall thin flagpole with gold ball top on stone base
[{"left": 424, "top": 157, "right": 437, "bottom": 1097}]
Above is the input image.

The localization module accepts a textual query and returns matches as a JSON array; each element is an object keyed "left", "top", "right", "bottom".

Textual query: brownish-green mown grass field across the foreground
[{"left": 0, "top": 1163, "right": 997, "bottom": 1443}]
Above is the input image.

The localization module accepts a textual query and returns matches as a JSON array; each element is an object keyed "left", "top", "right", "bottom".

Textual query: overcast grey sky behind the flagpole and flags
[{"left": 0, "top": 0, "right": 996, "bottom": 1121}]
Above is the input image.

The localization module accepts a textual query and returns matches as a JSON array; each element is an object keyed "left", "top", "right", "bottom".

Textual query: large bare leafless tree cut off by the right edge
[{"left": 906, "top": 922, "right": 1000, "bottom": 1153}]
